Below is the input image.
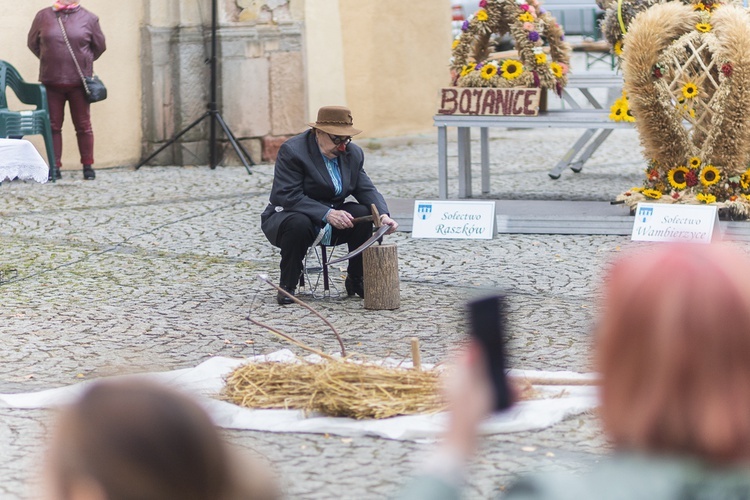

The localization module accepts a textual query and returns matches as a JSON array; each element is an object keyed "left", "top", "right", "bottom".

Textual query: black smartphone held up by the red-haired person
[{"left": 468, "top": 295, "right": 513, "bottom": 411}]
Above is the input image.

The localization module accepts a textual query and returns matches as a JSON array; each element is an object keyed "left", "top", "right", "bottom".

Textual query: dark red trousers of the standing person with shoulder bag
[{"left": 46, "top": 85, "right": 94, "bottom": 168}]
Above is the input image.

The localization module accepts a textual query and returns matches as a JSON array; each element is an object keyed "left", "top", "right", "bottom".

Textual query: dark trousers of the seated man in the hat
[{"left": 277, "top": 203, "right": 372, "bottom": 290}]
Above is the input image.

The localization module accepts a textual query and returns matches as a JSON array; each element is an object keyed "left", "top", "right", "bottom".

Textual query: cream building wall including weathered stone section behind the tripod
[{"left": 0, "top": 0, "right": 450, "bottom": 169}]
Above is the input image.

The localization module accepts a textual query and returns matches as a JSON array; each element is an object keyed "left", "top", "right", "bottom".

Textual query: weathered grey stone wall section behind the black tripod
[{"left": 142, "top": 0, "right": 306, "bottom": 165}]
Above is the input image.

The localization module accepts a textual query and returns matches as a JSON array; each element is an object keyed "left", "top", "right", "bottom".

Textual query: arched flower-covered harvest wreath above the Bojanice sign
[{"left": 450, "top": 0, "right": 571, "bottom": 95}]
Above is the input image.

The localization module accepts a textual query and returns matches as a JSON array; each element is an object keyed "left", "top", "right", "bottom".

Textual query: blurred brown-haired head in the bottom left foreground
[{"left": 45, "top": 380, "right": 277, "bottom": 500}]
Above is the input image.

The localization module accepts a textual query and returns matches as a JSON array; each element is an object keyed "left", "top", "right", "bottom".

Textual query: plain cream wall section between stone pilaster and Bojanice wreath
[{"left": 305, "top": 0, "right": 452, "bottom": 138}]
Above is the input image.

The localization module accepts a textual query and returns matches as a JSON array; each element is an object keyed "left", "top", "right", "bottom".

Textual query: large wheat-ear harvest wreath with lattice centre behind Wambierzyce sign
[{"left": 618, "top": 2, "right": 750, "bottom": 218}]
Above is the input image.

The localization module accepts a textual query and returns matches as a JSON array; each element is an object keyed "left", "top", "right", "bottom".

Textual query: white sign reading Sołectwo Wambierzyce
[{"left": 630, "top": 203, "right": 719, "bottom": 243}]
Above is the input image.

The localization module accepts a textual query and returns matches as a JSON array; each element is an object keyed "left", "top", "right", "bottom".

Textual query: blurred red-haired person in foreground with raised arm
[{"left": 400, "top": 244, "right": 750, "bottom": 500}]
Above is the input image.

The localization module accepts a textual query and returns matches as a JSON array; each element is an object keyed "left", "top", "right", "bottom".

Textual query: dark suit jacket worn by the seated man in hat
[{"left": 261, "top": 129, "right": 389, "bottom": 245}]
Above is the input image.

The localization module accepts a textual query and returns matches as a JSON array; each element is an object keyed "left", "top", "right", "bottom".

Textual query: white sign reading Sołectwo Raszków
[{"left": 411, "top": 200, "right": 495, "bottom": 240}]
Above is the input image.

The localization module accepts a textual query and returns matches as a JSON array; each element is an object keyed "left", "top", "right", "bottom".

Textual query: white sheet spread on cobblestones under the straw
[{"left": 0, "top": 349, "right": 597, "bottom": 441}]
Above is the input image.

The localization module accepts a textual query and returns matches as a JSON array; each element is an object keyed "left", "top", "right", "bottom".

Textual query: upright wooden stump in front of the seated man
[{"left": 362, "top": 245, "right": 401, "bottom": 310}]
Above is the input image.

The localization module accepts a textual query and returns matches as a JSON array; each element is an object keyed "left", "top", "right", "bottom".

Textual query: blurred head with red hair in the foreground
[{"left": 596, "top": 244, "right": 750, "bottom": 462}]
